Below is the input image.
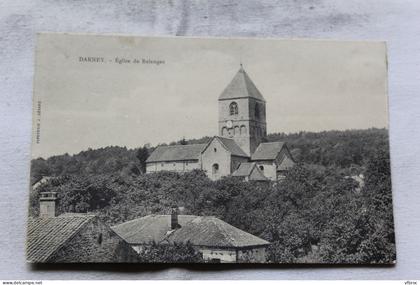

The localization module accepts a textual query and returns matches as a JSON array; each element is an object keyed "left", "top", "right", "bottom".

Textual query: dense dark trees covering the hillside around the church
[{"left": 29, "top": 129, "right": 395, "bottom": 263}]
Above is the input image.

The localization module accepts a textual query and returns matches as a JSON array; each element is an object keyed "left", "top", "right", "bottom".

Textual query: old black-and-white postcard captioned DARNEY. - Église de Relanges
[{"left": 27, "top": 33, "right": 396, "bottom": 264}]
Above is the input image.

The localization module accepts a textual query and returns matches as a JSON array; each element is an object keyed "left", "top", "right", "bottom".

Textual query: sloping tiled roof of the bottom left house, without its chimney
[{"left": 26, "top": 213, "right": 95, "bottom": 262}]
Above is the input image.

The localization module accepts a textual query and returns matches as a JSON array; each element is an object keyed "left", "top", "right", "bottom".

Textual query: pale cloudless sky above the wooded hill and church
[{"left": 32, "top": 34, "right": 388, "bottom": 158}]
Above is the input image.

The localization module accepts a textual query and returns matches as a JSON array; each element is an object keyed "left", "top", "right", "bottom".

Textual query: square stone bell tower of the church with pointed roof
[{"left": 219, "top": 64, "right": 267, "bottom": 156}]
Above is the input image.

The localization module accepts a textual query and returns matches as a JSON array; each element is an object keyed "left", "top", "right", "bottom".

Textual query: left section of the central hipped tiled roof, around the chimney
[{"left": 112, "top": 215, "right": 196, "bottom": 244}]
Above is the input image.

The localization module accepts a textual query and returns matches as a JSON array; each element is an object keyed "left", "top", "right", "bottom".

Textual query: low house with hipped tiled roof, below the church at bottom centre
[{"left": 112, "top": 211, "right": 270, "bottom": 263}]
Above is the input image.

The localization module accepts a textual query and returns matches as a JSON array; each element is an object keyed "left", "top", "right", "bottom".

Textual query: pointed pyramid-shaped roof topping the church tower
[{"left": 219, "top": 64, "right": 265, "bottom": 102}]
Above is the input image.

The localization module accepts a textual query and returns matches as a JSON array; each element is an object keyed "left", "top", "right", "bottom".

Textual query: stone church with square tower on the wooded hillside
[{"left": 146, "top": 64, "right": 295, "bottom": 181}]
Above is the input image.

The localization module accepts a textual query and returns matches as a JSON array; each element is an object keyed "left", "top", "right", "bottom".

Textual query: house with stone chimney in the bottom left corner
[{"left": 26, "top": 192, "right": 138, "bottom": 263}]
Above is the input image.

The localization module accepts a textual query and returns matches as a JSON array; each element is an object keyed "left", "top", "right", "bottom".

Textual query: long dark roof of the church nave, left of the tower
[{"left": 146, "top": 144, "right": 207, "bottom": 162}]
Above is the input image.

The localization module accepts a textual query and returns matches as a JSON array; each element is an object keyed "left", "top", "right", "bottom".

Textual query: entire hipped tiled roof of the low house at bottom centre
[{"left": 113, "top": 215, "right": 269, "bottom": 247}]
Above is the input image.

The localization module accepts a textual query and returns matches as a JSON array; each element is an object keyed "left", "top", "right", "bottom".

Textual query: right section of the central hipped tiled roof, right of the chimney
[{"left": 168, "top": 216, "right": 269, "bottom": 247}]
